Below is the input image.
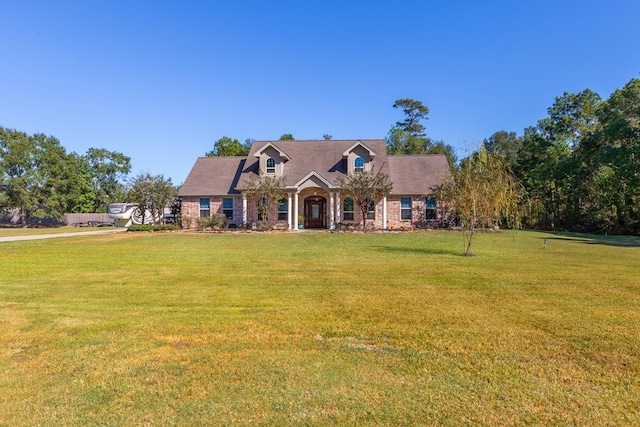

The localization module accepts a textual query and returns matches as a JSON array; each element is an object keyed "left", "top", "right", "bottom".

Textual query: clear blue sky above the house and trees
[{"left": 0, "top": 0, "right": 640, "bottom": 184}]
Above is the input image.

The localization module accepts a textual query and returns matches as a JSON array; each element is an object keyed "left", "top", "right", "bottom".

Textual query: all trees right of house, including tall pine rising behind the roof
[{"left": 387, "top": 79, "right": 640, "bottom": 237}]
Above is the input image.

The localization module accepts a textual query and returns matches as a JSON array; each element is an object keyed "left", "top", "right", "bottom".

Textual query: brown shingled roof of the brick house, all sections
[{"left": 179, "top": 139, "right": 450, "bottom": 196}]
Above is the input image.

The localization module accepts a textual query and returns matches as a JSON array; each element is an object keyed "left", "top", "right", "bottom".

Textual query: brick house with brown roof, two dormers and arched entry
[{"left": 179, "top": 139, "right": 450, "bottom": 230}]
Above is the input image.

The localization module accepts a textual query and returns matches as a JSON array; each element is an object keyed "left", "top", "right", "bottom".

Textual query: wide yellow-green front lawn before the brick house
[{"left": 0, "top": 232, "right": 640, "bottom": 425}]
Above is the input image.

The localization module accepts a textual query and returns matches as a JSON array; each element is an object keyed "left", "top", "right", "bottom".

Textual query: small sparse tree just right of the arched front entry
[{"left": 340, "top": 170, "right": 392, "bottom": 230}]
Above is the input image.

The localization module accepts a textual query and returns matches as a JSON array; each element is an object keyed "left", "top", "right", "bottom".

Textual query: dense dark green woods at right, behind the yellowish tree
[{"left": 484, "top": 79, "right": 640, "bottom": 234}]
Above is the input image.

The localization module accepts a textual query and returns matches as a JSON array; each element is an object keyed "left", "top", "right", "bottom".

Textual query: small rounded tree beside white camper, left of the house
[{"left": 127, "top": 172, "right": 178, "bottom": 227}]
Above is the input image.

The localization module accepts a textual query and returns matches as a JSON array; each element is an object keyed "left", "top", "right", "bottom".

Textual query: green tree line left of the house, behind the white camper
[{"left": 0, "top": 127, "right": 177, "bottom": 225}]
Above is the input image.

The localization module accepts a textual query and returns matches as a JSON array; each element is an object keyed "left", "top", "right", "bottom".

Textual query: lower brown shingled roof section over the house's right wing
[{"left": 387, "top": 154, "right": 451, "bottom": 195}]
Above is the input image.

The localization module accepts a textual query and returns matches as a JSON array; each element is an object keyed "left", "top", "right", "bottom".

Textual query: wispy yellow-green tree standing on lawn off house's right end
[{"left": 439, "top": 147, "right": 523, "bottom": 255}]
